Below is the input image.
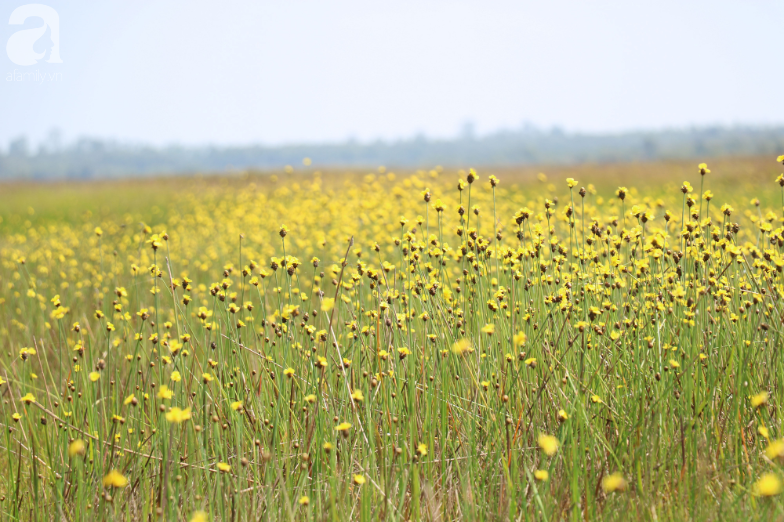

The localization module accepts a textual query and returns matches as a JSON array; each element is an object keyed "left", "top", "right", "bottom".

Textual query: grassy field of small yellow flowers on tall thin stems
[{"left": 0, "top": 157, "right": 784, "bottom": 522}]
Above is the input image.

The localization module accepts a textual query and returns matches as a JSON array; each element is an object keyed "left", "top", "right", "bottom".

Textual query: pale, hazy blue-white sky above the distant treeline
[{"left": 0, "top": 0, "right": 784, "bottom": 149}]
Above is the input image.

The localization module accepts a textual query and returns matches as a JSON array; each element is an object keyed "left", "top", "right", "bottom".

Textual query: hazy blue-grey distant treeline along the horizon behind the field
[{"left": 0, "top": 127, "right": 784, "bottom": 179}]
